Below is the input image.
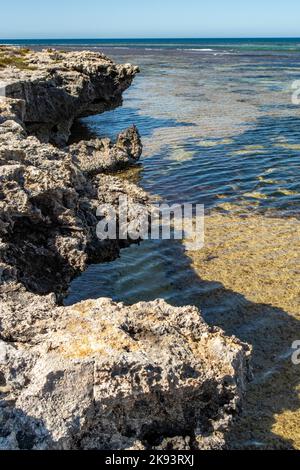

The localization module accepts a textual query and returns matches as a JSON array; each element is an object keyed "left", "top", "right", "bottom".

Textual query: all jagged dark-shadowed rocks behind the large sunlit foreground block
[{"left": 0, "top": 48, "right": 144, "bottom": 294}]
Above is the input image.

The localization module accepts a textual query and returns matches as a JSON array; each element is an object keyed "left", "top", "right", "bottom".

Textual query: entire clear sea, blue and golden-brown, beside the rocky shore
[{"left": 66, "top": 41, "right": 300, "bottom": 448}]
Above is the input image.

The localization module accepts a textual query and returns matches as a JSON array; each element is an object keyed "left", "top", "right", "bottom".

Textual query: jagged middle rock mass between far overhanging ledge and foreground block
[{"left": 0, "top": 99, "right": 148, "bottom": 294}]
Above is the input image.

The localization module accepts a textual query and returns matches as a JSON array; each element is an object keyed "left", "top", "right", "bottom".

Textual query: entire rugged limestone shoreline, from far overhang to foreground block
[{"left": 0, "top": 47, "right": 250, "bottom": 450}]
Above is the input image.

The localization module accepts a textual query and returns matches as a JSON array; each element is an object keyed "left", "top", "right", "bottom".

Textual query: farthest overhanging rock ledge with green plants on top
[{"left": 0, "top": 47, "right": 138, "bottom": 144}]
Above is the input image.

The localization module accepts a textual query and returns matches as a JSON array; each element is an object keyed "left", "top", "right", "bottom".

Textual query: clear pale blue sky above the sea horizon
[{"left": 0, "top": 0, "right": 300, "bottom": 39}]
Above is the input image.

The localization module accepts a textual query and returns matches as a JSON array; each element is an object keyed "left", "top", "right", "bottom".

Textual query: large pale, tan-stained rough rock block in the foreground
[{"left": 0, "top": 299, "right": 248, "bottom": 449}]
